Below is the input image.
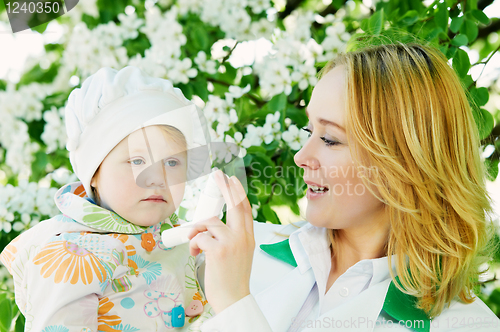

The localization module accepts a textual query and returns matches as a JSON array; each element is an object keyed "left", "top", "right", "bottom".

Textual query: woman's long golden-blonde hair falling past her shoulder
[{"left": 320, "top": 42, "right": 493, "bottom": 318}]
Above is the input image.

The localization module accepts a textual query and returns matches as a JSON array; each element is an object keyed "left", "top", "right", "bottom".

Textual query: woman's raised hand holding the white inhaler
[{"left": 188, "top": 170, "right": 255, "bottom": 313}]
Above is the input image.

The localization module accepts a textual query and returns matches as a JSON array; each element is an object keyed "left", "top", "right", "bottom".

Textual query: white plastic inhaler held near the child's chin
[{"left": 161, "top": 172, "right": 226, "bottom": 248}]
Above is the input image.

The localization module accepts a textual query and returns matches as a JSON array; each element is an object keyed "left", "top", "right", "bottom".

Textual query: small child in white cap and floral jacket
[{"left": 0, "top": 66, "right": 212, "bottom": 332}]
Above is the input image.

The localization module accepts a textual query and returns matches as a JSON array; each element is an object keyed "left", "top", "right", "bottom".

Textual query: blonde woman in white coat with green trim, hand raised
[{"left": 190, "top": 43, "right": 500, "bottom": 331}]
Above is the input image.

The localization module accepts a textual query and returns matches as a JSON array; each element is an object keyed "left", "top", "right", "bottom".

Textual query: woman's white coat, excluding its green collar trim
[{"left": 200, "top": 222, "right": 500, "bottom": 332}]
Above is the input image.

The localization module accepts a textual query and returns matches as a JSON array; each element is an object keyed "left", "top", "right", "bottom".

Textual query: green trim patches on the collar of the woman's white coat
[{"left": 260, "top": 239, "right": 431, "bottom": 332}]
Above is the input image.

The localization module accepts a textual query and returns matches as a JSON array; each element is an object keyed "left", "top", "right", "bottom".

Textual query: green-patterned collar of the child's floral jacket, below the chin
[{"left": 54, "top": 182, "right": 179, "bottom": 234}]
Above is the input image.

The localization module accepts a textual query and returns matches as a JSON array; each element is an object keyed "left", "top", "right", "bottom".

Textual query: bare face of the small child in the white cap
[{"left": 91, "top": 126, "right": 187, "bottom": 226}]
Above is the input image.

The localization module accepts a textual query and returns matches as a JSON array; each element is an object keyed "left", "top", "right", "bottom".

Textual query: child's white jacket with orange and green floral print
[{"left": 0, "top": 182, "right": 213, "bottom": 332}]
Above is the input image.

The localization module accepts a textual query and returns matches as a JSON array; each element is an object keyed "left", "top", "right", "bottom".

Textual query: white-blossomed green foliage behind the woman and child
[{"left": 0, "top": 0, "right": 500, "bottom": 331}]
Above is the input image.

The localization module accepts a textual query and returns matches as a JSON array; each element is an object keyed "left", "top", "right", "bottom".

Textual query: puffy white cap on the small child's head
[{"left": 65, "top": 66, "right": 211, "bottom": 199}]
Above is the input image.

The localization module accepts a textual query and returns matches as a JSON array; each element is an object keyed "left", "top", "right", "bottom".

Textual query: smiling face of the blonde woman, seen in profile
[{"left": 294, "top": 66, "right": 386, "bottom": 231}]
